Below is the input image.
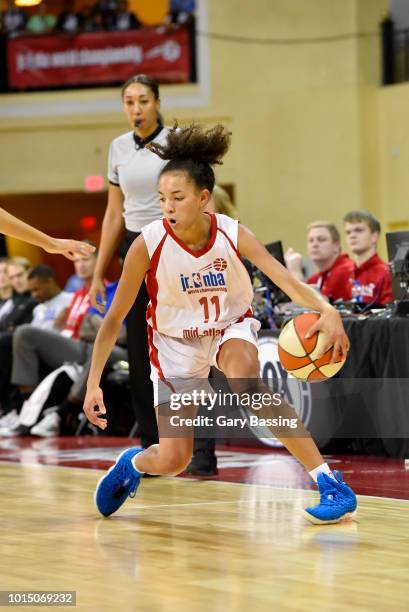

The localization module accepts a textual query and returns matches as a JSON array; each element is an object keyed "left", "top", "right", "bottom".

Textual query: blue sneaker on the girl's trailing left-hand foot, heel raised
[{"left": 94, "top": 448, "right": 143, "bottom": 516}]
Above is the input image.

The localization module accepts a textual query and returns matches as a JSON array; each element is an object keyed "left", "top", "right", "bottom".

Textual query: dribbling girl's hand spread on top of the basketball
[{"left": 306, "top": 305, "right": 350, "bottom": 363}]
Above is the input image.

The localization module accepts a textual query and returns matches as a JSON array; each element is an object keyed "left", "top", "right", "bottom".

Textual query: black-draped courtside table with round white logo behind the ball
[{"left": 259, "top": 317, "right": 409, "bottom": 457}]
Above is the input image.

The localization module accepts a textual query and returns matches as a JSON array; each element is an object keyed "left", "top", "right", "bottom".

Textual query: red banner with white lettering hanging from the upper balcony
[{"left": 8, "top": 28, "right": 190, "bottom": 89}]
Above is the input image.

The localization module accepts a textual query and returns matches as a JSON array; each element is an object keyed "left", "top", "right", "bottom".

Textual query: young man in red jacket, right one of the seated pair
[{"left": 344, "top": 210, "right": 393, "bottom": 305}]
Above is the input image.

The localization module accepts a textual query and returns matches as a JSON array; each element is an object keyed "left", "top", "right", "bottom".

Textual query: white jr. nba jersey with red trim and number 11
[{"left": 142, "top": 214, "right": 253, "bottom": 339}]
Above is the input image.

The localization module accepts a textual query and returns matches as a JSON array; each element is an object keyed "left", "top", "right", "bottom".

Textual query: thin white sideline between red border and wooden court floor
[{"left": 0, "top": 459, "right": 409, "bottom": 508}]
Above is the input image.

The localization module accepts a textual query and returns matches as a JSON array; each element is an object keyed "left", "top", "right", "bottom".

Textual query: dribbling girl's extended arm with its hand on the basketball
[{"left": 238, "top": 225, "right": 349, "bottom": 360}]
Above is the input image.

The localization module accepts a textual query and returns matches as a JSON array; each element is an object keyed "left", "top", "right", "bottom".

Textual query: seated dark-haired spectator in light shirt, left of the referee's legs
[{"left": 28, "top": 265, "right": 72, "bottom": 329}]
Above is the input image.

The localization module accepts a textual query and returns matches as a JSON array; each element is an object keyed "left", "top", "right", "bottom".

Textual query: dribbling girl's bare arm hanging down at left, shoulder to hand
[{"left": 84, "top": 236, "right": 150, "bottom": 429}]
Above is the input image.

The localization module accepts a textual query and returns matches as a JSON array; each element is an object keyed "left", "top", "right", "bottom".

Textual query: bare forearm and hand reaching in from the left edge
[{"left": 0, "top": 208, "right": 95, "bottom": 260}]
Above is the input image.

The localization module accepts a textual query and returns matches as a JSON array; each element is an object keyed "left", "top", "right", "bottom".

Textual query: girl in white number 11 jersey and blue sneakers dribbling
[{"left": 84, "top": 125, "right": 356, "bottom": 523}]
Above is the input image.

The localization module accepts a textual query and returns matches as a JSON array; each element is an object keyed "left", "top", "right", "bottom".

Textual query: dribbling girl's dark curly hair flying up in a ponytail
[{"left": 148, "top": 122, "right": 231, "bottom": 193}]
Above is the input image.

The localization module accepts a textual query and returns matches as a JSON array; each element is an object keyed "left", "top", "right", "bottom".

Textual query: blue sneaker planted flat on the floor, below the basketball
[{"left": 304, "top": 472, "right": 357, "bottom": 525}]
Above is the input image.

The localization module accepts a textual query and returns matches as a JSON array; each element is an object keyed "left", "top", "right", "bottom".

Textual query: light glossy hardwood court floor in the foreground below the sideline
[{"left": 0, "top": 462, "right": 409, "bottom": 612}]
